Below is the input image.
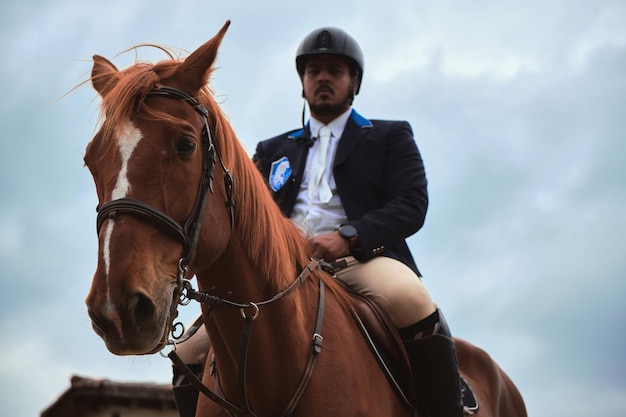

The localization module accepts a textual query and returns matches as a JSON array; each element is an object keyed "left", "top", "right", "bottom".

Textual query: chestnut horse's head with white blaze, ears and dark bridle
[{"left": 84, "top": 18, "right": 232, "bottom": 355}]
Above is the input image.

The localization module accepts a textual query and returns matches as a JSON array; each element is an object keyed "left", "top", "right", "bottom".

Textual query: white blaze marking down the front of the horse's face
[{"left": 102, "top": 122, "right": 142, "bottom": 305}]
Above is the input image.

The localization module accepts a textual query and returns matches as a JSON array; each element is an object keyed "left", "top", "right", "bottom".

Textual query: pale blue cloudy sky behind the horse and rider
[{"left": 0, "top": 0, "right": 626, "bottom": 417}]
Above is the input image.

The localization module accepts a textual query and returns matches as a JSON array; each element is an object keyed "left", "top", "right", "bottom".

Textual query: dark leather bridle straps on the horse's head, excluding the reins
[{"left": 96, "top": 86, "right": 235, "bottom": 353}]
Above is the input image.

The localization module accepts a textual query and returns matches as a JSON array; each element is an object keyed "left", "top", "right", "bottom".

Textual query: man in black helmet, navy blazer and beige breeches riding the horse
[{"left": 173, "top": 27, "right": 463, "bottom": 417}]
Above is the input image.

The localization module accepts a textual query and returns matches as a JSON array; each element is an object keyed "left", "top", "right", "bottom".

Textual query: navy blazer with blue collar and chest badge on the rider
[{"left": 253, "top": 110, "right": 428, "bottom": 276}]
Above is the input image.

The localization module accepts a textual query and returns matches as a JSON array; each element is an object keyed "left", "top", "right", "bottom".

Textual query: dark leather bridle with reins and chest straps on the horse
[{"left": 96, "top": 86, "right": 325, "bottom": 417}]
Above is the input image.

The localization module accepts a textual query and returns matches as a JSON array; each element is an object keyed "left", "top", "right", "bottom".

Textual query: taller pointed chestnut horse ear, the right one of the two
[{"left": 176, "top": 20, "right": 230, "bottom": 92}]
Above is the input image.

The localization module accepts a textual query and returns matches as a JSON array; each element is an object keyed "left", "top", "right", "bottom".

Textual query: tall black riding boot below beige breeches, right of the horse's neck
[{"left": 404, "top": 310, "right": 463, "bottom": 417}]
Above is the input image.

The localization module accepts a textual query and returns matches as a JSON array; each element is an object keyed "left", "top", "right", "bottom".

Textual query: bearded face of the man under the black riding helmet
[{"left": 302, "top": 54, "right": 356, "bottom": 120}]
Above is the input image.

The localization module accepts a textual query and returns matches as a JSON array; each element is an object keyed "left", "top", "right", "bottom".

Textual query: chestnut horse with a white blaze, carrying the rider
[{"left": 84, "top": 21, "right": 526, "bottom": 417}]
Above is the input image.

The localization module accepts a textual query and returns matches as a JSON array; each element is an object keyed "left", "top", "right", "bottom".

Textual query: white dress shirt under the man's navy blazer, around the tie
[{"left": 291, "top": 108, "right": 352, "bottom": 237}]
